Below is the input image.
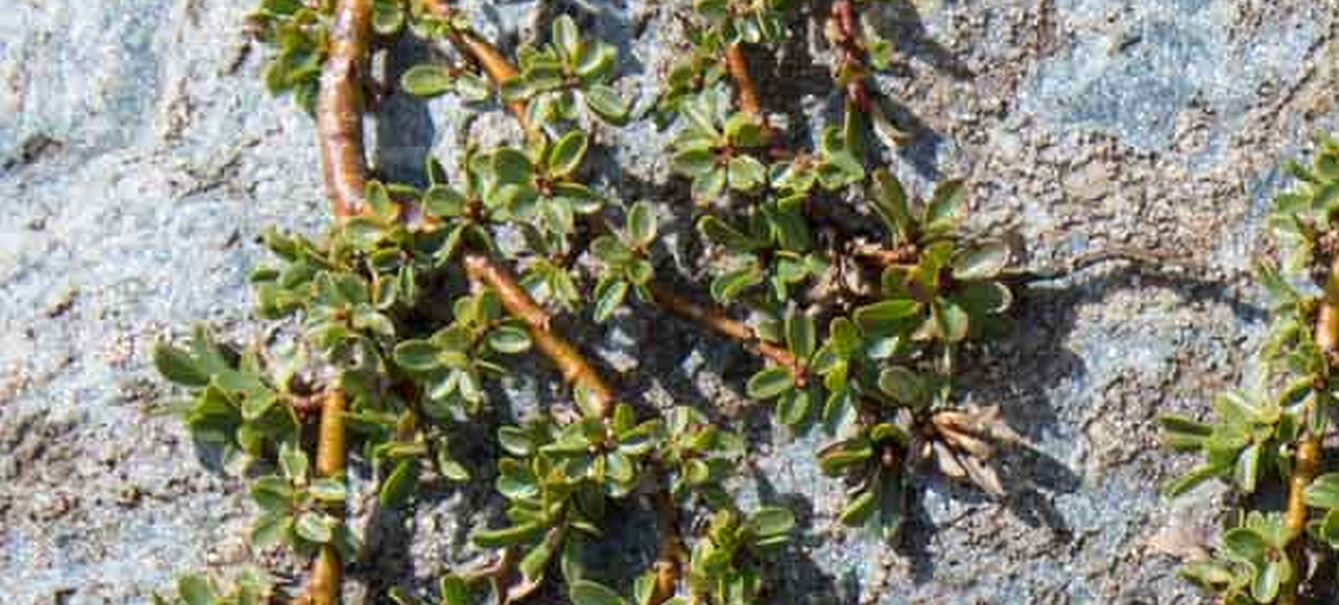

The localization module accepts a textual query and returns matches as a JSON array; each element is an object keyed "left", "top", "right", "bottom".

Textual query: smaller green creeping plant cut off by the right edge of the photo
[{"left": 1162, "top": 138, "right": 1339, "bottom": 605}]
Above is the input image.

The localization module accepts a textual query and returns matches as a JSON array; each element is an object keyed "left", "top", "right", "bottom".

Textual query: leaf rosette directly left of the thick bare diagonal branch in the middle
[{"left": 394, "top": 290, "right": 530, "bottom": 418}]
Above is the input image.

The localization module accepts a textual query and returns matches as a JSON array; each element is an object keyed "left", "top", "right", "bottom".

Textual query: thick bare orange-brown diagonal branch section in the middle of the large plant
[{"left": 462, "top": 253, "right": 615, "bottom": 416}]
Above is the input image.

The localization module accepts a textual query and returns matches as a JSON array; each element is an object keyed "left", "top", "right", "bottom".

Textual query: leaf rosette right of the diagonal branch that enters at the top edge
[{"left": 502, "top": 15, "right": 631, "bottom": 126}]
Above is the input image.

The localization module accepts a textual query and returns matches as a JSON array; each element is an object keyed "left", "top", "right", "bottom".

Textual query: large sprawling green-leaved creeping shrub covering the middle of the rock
[{"left": 154, "top": 0, "right": 1033, "bottom": 605}]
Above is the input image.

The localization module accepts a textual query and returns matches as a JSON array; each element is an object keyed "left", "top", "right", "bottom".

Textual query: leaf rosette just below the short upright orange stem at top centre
[{"left": 671, "top": 86, "right": 767, "bottom": 202}]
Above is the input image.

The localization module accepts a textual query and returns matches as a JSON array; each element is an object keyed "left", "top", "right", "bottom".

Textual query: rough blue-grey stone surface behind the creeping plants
[{"left": 0, "top": 0, "right": 1339, "bottom": 605}]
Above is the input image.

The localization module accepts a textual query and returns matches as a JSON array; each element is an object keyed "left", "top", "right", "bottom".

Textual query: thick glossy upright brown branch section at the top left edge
[{"left": 316, "top": 0, "right": 372, "bottom": 222}]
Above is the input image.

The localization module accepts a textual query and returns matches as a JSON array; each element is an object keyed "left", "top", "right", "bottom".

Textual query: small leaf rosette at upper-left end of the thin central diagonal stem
[{"left": 590, "top": 202, "right": 656, "bottom": 323}]
